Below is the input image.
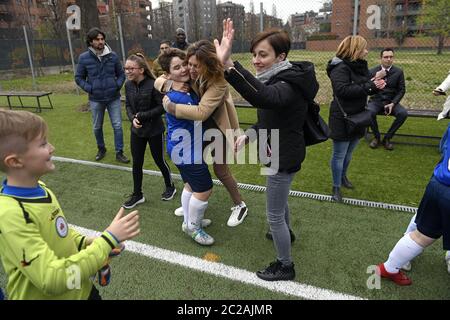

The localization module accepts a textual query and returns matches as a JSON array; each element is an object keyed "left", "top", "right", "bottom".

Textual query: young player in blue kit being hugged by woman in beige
[{"left": 158, "top": 49, "right": 214, "bottom": 245}]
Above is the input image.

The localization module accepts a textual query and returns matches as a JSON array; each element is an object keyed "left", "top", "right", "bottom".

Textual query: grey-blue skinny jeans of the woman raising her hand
[{"left": 266, "top": 172, "right": 295, "bottom": 265}]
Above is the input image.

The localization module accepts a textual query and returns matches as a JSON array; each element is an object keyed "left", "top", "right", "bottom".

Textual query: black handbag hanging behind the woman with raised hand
[{"left": 303, "top": 101, "right": 331, "bottom": 146}]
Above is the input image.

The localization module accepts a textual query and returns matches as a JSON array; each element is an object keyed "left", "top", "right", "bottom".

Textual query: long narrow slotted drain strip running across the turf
[{"left": 52, "top": 157, "right": 417, "bottom": 214}]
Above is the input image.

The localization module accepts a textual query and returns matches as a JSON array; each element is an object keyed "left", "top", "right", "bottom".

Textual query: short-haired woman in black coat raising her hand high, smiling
[{"left": 215, "top": 19, "right": 319, "bottom": 281}]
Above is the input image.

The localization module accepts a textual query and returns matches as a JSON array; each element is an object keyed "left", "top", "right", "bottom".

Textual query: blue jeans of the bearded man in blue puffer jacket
[{"left": 89, "top": 98, "right": 123, "bottom": 152}]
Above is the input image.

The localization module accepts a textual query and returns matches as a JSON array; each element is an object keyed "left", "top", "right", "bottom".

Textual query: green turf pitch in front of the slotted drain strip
[{"left": 0, "top": 162, "right": 450, "bottom": 300}]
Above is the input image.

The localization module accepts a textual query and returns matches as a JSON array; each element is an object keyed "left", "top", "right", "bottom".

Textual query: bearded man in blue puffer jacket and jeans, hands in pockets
[{"left": 75, "top": 28, "right": 130, "bottom": 163}]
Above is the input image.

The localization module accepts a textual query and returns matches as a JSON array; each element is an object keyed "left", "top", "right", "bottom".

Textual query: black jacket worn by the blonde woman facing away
[{"left": 327, "top": 57, "right": 378, "bottom": 141}]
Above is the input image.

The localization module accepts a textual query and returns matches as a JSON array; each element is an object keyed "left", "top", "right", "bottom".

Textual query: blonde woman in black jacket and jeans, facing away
[{"left": 327, "top": 36, "right": 385, "bottom": 202}]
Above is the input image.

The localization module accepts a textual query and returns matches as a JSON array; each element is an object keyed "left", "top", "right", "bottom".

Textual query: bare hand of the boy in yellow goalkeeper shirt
[{"left": 106, "top": 208, "right": 141, "bottom": 242}]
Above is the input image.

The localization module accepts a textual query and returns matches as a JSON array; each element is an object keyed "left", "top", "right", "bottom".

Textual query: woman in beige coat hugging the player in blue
[{"left": 155, "top": 40, "right": 248, "bottom": 227}]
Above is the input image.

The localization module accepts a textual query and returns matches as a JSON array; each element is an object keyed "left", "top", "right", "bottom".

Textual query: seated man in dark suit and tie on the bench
[{"left": 368, "top": 48, "right": 408, "bottom": 150}]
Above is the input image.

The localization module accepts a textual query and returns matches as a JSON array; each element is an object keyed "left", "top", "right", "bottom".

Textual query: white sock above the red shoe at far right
[{"left": 384, "top": 233, "right": 424, "bottom": 273}]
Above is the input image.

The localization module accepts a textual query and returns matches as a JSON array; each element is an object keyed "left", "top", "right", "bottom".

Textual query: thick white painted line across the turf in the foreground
[{"left": 71, "top": 225, "right": 363, "bottom": 300}]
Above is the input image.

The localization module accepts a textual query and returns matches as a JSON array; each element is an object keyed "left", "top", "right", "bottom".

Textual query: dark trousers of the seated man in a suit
[{"left": 368, "top": 101, "right": 408, "bottom": 139}]
